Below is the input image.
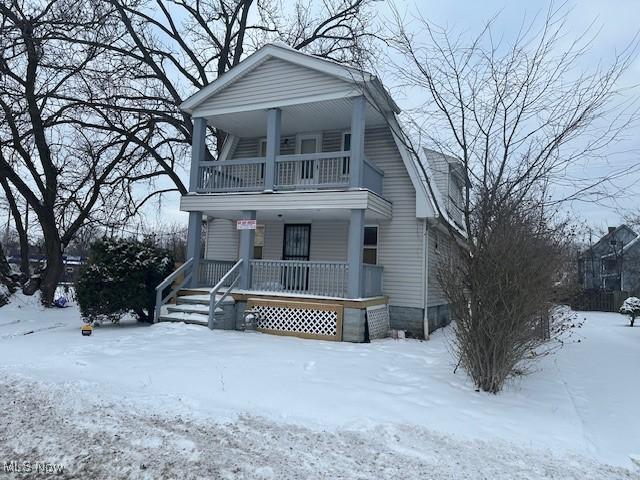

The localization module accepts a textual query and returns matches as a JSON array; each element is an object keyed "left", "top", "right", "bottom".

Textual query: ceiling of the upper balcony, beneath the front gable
[{"left": 207, "top": 98, "right": 385, "bottom": 137}]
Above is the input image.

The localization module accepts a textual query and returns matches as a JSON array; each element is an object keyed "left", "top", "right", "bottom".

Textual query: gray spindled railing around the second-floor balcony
[{"left": 196, "top": 151, "right": 383, "bottom": 194}]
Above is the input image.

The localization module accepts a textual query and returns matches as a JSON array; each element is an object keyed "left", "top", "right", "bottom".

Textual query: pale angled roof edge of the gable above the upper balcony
[{"left": 180, "top": 43, "right": 400, "bottom": 114}]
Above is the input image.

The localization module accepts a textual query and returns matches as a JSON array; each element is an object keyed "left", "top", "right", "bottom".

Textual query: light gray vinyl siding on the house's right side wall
[{"left": 364, "top": 127, "right": 424, "bottom": 308}]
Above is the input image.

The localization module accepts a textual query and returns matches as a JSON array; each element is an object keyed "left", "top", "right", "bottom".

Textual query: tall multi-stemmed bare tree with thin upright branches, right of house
[{"left": 382, "top": 4, "right": 637, "bottom": 392}]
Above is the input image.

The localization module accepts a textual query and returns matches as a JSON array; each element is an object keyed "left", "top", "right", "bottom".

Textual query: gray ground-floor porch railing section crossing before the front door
[{"left": 251, "top": 260, "right": 348, "bottom": 298}]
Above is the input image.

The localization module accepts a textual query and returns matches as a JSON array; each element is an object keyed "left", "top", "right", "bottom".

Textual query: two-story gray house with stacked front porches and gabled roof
[{"left": 159, "top": 44, "right": 463, "bottom": 341}]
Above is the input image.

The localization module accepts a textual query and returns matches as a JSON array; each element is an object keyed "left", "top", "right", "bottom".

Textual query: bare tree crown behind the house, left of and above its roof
[{"left": 58, "top": 0, "right": 384, "bottom": 194}]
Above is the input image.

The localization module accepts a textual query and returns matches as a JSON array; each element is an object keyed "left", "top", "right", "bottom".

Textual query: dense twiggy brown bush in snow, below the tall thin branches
[{"left": 440, "top": 194, "right": 567, "bottom": 393}]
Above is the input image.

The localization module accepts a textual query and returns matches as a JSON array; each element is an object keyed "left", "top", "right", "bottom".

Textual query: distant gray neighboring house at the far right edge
[{"left": 578, "top": 225, "right": 640, "bottom": 294}]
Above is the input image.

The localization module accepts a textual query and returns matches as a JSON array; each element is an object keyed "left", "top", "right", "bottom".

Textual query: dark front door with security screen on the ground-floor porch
[{"left": 281, "top": 223, "right": 311, "bottom": 292}]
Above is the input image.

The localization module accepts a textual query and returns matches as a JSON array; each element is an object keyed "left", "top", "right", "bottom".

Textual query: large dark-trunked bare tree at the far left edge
[{"left": 0, "top": 0, "right": 155, "bottom": 305}]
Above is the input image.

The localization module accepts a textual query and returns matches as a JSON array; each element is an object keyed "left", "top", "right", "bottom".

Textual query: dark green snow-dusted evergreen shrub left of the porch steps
[{"left": 76, "top": 239, "right": 174, "bottom": 322}]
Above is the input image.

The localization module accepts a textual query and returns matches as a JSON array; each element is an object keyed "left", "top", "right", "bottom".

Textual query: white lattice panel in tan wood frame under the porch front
[{"left": 247, "top": 299, "right": 343, "bottom": 341}]
